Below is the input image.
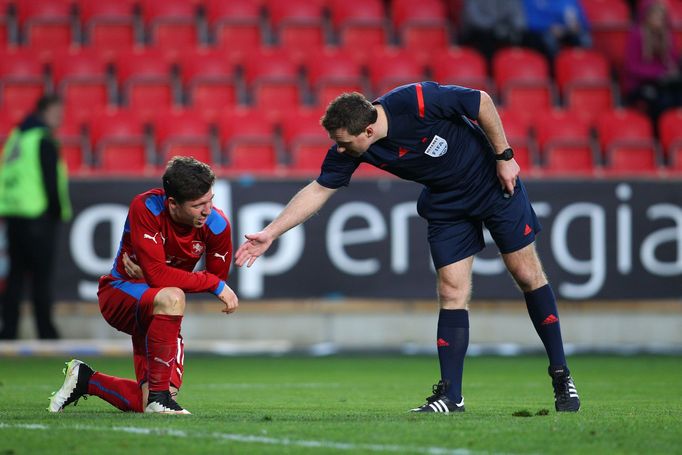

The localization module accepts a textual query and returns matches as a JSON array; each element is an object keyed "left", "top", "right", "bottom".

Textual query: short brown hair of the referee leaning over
[{"left": 320, "top": 92, "right": 379, "bottom": 136}]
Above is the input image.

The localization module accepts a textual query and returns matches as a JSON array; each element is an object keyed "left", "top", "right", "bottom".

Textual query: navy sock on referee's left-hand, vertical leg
[{"left": 438, "top": 310, "right": 469, "bottom": 403}]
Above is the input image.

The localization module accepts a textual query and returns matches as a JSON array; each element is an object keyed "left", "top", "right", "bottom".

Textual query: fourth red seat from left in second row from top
[{"left": 180, "top": 49, "right": 238, "bottom": 118}]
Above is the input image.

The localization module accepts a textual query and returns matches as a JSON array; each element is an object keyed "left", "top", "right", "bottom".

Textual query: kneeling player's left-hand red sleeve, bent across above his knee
[{"left": 128, "top": 198, "right": 222, "bottom": 293}]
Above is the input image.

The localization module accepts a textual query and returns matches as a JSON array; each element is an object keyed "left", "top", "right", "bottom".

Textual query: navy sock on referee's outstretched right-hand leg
[{"left": 523, "top": 284, "right": 566, "bottom": 366}]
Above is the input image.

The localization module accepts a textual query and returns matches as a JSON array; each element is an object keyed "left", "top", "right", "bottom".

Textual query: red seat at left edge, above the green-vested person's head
[{"left": 0, "top": 49, "right": 45, "bottom": 122}]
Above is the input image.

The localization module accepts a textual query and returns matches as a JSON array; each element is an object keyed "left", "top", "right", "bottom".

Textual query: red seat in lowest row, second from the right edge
[{"left": 596, "top": 109, "right": 653, "bottom": 157}]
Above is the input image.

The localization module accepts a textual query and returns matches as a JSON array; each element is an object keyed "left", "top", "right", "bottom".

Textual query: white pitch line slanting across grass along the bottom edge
[{"left": 0, "top": 422, "right": 487, "bottom": 455}]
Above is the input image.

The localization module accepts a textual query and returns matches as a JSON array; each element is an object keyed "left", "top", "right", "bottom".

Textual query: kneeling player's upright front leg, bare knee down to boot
[{"left": 145, "top": 288, "right": 189, "bottom": 414}]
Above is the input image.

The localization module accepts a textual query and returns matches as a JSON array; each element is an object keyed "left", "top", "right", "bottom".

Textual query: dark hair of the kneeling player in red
[{"left": 163, "top": 156, "right": 215, "bottom": 204}]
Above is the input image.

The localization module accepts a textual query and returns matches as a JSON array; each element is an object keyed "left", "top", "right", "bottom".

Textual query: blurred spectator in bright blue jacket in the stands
[{"left": 523, "top": 0, "right": 592, "bottom": 59}]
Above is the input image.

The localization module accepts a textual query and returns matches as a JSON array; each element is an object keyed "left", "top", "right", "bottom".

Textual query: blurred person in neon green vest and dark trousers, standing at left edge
[{"left": 0, "top": 95, "right": 71, "bottom": 339}]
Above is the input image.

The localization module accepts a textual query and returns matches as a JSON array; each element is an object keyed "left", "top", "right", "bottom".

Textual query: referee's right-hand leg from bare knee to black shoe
[{"left": 502, "top": 244, "right": 580, "bottom": 412}]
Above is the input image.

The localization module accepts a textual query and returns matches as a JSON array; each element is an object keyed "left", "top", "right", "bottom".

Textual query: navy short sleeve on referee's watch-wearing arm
[{"left": 415, "top": 82, "right": 481, "bottom": 119}]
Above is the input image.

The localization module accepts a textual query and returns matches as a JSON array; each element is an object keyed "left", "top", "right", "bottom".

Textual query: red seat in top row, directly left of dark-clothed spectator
[{"left": 391, "top": 0, "right": 450, "bottom": 61}]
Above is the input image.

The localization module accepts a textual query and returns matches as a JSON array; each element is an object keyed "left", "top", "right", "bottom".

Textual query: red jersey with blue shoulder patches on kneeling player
[{"left": 100, "top": 188, "right": 232, "bottom": 295}]
